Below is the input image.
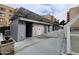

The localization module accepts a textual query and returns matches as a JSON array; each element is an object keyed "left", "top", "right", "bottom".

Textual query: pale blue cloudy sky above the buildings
[{"left": 7, "top": 4, "right": 78, "bottom": 21}]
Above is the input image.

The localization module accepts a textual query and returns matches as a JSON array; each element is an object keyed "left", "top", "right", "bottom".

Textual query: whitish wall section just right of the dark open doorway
[{"left": 32, "top": 23, "right": 44, "bottom": 36}]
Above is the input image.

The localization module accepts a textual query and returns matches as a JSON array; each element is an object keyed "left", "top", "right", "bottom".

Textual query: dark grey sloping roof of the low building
[{"left": 12, "top": 7, "right": 49, "bottom": 23}]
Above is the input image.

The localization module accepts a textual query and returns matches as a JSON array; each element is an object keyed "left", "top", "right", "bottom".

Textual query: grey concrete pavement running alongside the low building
[{"left": 15, "top": 30, "right": 65, "bottom": 55}]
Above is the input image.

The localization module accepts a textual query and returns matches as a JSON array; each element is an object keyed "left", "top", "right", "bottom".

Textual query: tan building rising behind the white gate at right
[{"left": 67, "top": 6, "right": 79, "bottom": 27}]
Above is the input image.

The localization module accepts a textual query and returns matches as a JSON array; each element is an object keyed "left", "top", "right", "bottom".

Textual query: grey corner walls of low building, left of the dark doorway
[{"left": 10, "top": 19, "right": 26, "bottom": 41}]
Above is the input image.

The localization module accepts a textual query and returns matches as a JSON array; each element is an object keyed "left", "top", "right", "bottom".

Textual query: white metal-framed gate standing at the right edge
[{"left": 64, "top": 15, "right": 79, "bottom": 54}]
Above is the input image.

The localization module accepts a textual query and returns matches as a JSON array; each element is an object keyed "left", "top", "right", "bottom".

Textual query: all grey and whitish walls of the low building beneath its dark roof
[{"left": 11, "top": 19, "right": 52, "bottom": 41}]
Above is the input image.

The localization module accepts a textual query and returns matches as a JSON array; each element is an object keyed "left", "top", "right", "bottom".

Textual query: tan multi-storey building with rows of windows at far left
[{"left": 0, "top": 4, "right": 15, "bottom": 27}]
